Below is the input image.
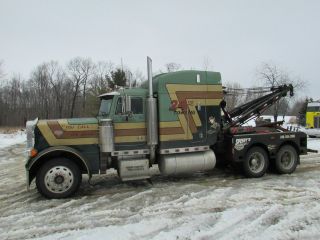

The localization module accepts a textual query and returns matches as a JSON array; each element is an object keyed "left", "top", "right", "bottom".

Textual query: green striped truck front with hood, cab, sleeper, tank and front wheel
[{"left": 26, "top": 57, "right": 222, "bottom": 198}]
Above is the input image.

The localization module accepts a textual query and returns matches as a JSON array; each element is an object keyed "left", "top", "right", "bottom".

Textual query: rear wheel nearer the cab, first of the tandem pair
[{"left": 242, "top": 147, "right": 269, "bottom": 178}]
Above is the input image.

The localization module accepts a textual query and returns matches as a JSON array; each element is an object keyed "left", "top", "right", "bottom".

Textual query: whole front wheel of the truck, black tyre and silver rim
[{"left": 36, "top": 158, "right": 82, "bottom": 199}]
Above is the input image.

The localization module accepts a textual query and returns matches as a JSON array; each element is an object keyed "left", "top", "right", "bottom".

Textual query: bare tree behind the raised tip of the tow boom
[{"left": 257, "top": 63, "right": 306, "bottom": 122}]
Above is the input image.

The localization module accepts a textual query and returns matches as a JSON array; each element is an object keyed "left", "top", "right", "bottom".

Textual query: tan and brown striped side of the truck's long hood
[{"left": 37, "top": 118, "right": 99, "bottom": 146}]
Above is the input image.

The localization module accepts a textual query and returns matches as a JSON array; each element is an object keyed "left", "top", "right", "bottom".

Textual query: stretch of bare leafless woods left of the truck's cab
[{"left": 0, "top": 57, "right": 144, "bottom": 126}]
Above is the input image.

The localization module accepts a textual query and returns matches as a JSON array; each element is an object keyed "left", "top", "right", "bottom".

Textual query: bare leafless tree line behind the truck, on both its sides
[{"left": 0, "top": 57, "right": 307, "bottom": 126}]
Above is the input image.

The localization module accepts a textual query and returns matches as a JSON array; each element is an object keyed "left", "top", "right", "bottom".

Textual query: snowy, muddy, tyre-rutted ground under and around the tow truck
[{"left": 0, "top": 132, "right": 320, "bottom": 240}]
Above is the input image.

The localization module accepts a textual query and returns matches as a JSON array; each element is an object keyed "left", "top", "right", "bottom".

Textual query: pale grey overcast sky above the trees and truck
[{"left": 0, "top": 0, "right": 320, "bottom": 99}]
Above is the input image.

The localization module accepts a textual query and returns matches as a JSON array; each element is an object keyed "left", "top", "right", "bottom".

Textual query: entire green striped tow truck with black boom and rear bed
[{"left": 25, "top": 57, "right": 307, "bottom": 198}]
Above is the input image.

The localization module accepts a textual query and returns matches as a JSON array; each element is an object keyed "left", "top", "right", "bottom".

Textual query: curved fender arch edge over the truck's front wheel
[{"left": 25, "top": 146, "right": 92, "bottom": 190}]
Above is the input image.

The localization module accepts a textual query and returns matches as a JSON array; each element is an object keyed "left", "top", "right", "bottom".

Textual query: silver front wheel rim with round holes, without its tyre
[{"left": 44, "top": 166, "right": 74, "bottom": 193}]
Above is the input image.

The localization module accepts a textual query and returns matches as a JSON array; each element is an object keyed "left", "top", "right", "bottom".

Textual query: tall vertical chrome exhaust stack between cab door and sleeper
[{"left": 146, "top": 57, "right": 158, "bottom": 165}]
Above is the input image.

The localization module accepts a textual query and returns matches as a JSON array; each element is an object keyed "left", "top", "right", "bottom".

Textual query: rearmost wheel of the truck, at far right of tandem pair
[{"left": 275, "top": 145, "right": 298, "bottom": 174}]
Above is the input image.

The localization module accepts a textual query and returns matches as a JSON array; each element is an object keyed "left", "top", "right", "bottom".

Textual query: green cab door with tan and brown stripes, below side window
[{"left": 113, "top": 96, "right": 147, "bottom": 151}]
